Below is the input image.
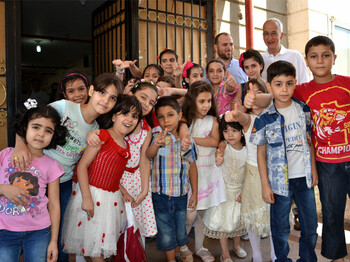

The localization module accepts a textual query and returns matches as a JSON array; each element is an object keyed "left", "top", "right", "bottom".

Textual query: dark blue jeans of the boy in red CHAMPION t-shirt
[{"left": 316, "top": 162, "right": 350, "bottom": 259}]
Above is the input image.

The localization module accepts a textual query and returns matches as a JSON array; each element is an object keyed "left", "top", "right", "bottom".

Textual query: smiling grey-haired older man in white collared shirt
[{"left": 262, "top": 18, "right": 309, "bottom": 84}]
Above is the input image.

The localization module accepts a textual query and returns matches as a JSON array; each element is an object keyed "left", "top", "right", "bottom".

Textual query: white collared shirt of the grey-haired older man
[{"left": 261, "top": 45, "right": 309, "bottom": 85}]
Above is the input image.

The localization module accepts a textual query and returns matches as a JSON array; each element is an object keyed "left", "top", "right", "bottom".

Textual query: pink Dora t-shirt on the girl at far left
[{"left": 0, "top": 147, "right": 64, "bottom": 232}]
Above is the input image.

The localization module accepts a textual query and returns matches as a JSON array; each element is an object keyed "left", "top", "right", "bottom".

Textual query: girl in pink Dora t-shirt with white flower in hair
[{"left": 0, "top": 99, "right": 67, "bottom": 262}]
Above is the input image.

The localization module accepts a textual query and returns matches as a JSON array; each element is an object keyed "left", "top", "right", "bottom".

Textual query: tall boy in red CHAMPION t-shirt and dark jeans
[{"left": 294, "top": 36, "right": 350, "bottom": 261}]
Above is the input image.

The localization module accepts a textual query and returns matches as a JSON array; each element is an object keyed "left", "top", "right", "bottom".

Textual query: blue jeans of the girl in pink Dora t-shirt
[{"left": 0, "top": 227, "right": 51, "bottom": 262}]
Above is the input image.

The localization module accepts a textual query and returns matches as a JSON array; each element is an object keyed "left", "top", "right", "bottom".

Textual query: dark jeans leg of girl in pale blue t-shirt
[{"left": 57, "top": 180, "right": 72, "bottom": 262}]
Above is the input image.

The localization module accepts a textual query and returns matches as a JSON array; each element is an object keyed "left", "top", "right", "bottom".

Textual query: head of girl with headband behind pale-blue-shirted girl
[{"left": 60, "top": 71, "right": 89, "bottom": 104}]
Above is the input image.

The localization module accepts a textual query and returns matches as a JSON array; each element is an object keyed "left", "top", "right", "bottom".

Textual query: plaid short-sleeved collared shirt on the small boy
[{"left": 151, "top": 133, "right": 197, "bottom": 196}]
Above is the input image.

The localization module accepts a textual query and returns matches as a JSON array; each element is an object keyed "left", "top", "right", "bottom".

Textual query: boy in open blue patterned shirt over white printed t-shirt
[{"left": 250, "top": 61, "right": 317, "bottom": 261}]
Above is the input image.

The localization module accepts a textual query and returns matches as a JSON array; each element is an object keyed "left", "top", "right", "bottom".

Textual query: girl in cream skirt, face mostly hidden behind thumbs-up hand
[{"left": 225, "top": 78, "right": 275, "bottom": 262}]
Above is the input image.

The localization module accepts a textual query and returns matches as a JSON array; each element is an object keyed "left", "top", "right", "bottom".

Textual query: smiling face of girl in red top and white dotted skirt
[{"left": 112, "top": 107, "right": 139, "bottom": 137}]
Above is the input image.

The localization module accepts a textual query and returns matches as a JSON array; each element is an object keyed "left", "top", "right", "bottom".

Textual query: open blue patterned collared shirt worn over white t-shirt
[{"left": 250, "top": 98, "right": 312, "bottom": 196}]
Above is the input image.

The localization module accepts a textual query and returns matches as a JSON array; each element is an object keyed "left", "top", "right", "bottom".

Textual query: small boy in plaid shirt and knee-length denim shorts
[{"left": 146, "top": 96, "right": 198, "bottom": 261}]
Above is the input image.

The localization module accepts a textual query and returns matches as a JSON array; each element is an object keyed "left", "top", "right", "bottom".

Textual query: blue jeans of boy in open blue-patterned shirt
[{"left": 270, "top": 177, "right": 317, "bottom": 262}]
